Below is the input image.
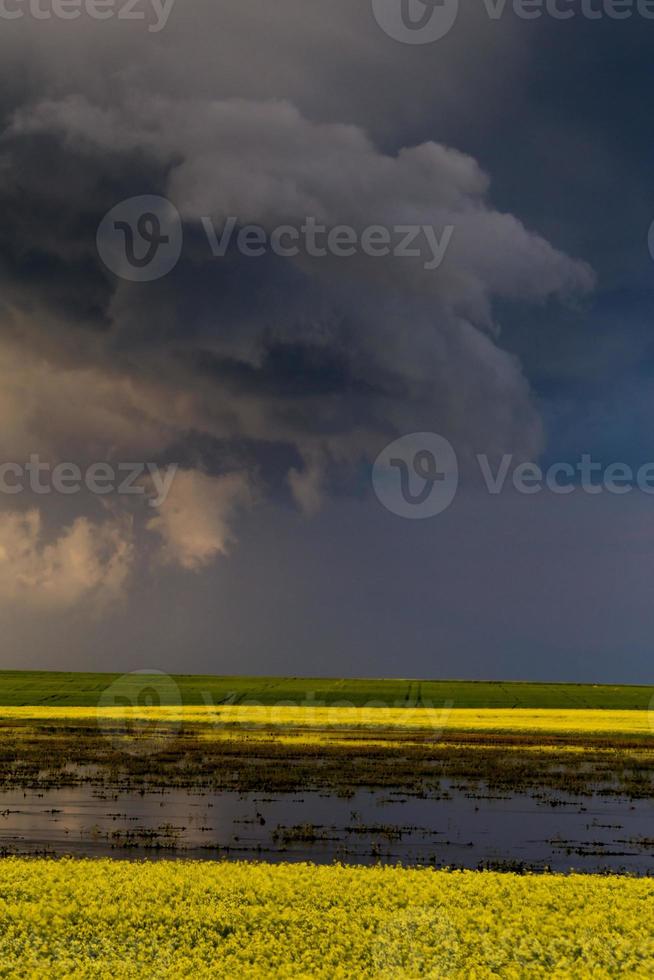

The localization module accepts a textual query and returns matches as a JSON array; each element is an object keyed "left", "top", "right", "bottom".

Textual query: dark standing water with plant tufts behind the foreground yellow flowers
[{"left": 5, "top": 784, "right": 654, "bottom": 874}]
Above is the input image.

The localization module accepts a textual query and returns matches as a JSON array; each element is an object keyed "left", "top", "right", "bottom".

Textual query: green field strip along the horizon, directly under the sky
[{"left": 0, "top": 670, "right": 654, "bottom": 709}]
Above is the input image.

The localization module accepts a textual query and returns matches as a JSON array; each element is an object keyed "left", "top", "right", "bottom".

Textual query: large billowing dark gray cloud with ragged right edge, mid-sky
[{"left": 3, "top": 96, "right": 593, "bottom": 482}]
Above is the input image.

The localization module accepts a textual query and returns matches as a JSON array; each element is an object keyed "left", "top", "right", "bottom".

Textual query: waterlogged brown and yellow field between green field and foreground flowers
[{"left": 0, "top": 708, "right": 654, "bottom": 875}]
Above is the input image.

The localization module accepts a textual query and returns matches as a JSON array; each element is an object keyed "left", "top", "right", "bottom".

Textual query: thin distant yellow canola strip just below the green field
[{"left": 5, "top": 705, "right": 654, "bottom": 736}]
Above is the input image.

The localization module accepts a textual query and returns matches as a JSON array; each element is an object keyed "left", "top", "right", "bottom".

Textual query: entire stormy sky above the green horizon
[{"left": 0, "top": 0, "right": 654, "bottom": 683}]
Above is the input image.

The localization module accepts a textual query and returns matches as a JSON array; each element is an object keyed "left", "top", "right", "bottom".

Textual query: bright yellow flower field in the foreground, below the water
[{"left": 0, "top": 858, "right": 654, "bottom": 980}]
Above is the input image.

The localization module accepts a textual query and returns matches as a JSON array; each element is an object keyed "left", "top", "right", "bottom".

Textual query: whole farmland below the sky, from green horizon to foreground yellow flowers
[{"left": 0, "top": 672, "right": 654, "bottom": 980}]
